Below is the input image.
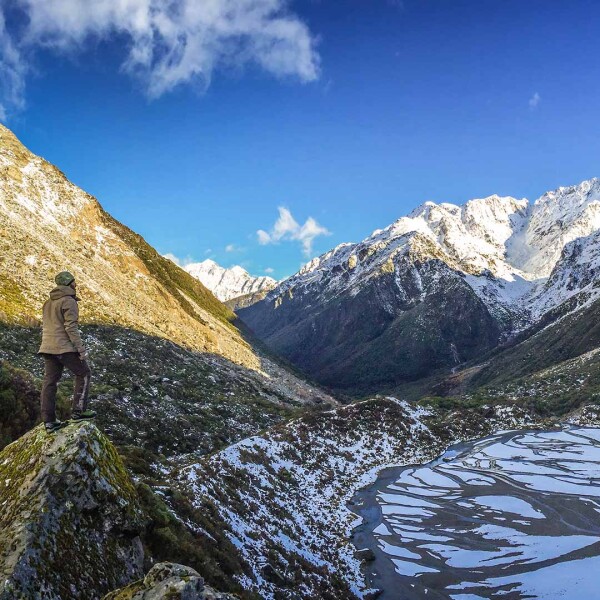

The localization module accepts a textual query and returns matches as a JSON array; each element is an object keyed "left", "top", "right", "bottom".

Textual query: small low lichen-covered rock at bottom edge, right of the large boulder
[{"left": 104, "top": 563, "right": 237, "bottom": 600}]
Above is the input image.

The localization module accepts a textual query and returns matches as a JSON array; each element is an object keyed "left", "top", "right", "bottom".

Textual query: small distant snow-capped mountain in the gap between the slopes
[{"left": 184, "top": 259, "right": 277, "bottom": 302}]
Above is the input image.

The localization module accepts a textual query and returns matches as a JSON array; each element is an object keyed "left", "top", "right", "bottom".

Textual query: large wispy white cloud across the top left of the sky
[{"left": 0, "top": 0, "right": 319, "bottom": 118}]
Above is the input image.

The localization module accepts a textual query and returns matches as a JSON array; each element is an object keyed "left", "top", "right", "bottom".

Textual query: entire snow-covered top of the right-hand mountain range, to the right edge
[{"left": 258, "top": 179, "right": 600, "bottom": 340}]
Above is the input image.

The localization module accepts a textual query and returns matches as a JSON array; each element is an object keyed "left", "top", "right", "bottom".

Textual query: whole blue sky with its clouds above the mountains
[{"left": 0, "top": 0, "right": 600, "bottom": 277}]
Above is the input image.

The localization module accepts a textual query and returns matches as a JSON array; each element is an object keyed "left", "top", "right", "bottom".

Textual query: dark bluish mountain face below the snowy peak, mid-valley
[{"left": 239, "top": 257, "right": 502, "bottom": 393}]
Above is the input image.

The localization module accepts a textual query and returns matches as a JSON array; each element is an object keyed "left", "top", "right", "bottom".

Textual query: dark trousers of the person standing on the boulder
[{"left": 42, "top": 352, "right": 91, "bottom": 423}]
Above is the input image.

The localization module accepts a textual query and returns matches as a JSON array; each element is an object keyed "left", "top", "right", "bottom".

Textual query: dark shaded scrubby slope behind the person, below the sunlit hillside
[{"left": 0, "top": 325, "right": 310, "bottom": 598}]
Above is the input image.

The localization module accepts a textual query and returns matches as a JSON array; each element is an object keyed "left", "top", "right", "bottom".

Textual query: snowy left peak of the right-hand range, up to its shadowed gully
[{"left": 274, "top": 196, "right": 529, "bottom": 304}]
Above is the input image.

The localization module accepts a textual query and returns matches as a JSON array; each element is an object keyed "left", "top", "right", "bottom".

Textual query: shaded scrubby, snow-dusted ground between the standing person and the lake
[{"left": 0, "top": 327, "right": 600, "bottom": 600}]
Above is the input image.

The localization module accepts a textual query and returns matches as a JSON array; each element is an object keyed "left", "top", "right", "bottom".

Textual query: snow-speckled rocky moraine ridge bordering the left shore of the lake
[{"left": 178, "top": 397, "right": 526, "bottom": 600}]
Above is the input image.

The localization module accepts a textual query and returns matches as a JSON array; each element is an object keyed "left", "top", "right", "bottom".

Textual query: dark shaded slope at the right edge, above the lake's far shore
[{"left": 422, "top": 301, "right": 600, "bottom": 415}]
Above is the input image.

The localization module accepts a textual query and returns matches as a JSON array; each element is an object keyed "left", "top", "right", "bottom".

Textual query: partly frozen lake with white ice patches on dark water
[{"left": 354, "top": 428, "right": 600, "bottom": 600}]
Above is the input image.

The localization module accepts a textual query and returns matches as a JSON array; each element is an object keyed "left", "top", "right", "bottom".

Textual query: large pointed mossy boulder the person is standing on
[{"left": 0, "top": 423, "right": 144, "bottom": 600}]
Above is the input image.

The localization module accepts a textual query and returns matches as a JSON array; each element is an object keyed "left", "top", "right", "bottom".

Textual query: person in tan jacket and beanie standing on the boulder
[{"left": 38, "top": 271, "right": 96, "bottom": 432}]
